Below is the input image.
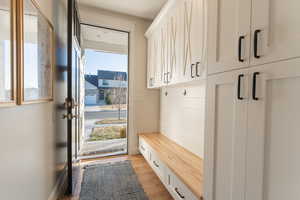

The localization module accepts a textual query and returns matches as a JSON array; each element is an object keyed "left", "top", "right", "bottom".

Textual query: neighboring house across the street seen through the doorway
[{"left": 85, "top": 70, "right": 128, "bottom": 105}]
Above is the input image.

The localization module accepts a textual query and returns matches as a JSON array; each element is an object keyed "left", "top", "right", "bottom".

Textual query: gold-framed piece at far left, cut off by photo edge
[{"left": 0, "top": 0, "right": 16, "bottom": 106}]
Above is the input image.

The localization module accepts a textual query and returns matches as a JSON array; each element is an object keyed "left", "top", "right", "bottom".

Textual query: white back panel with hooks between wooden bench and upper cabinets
[{"left": 160, "top": 82, "right": 206, "bottom": 158}]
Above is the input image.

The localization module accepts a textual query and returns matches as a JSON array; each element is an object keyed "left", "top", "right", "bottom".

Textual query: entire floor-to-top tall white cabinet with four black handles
[{"left": 204, "top": 0, "right": 300, "bottom": 200}]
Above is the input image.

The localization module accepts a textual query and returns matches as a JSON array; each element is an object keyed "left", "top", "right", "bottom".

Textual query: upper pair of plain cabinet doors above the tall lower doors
[{"left": 207, "top": 0, "right": 300, "bottom": 74}]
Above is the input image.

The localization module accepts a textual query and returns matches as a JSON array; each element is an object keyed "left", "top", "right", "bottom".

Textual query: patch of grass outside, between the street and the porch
[{"left": 88, "top": 126, "right": 126, "bottom": 141}]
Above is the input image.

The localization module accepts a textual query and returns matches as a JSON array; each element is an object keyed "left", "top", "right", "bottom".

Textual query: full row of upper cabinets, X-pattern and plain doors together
[{"left": 146, "top": 0, "right": 300, "bottom": 87}]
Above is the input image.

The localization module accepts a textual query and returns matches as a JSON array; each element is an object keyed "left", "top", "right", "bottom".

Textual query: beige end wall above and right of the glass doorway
[{"left": 79, "top": 6, "right": 159, "bottom": 154}]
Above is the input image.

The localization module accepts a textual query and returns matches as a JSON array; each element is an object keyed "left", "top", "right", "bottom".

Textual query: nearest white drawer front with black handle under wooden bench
[{"left": 167, "top": 169, "right": 199, "bottom": 200}]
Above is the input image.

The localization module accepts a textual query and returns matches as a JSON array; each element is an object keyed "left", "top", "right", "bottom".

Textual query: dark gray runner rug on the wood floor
[{"left": 80, "top": 161, "right": 148, "bottom": 200}]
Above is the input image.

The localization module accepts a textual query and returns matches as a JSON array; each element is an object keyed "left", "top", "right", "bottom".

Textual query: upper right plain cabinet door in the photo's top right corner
[{"left": 251, "top": 0, "right": 300, "bottom": 65}]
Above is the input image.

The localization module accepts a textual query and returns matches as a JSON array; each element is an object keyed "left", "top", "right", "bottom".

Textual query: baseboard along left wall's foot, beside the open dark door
[{"left": 48, "top": 167, "right": 68, "bottom": 200}]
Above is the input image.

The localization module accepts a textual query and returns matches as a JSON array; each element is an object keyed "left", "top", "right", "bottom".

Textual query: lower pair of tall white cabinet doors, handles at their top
[{"left": 204, "top": 59, "right": 300, "bottom": 200}]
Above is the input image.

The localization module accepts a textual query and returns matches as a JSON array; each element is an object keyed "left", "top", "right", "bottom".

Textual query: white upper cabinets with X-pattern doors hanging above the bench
[{"left": 146, "top": 0, "right": 207, "bottom": 88}]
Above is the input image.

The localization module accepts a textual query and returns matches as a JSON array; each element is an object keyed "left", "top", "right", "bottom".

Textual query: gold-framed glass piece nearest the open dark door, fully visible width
[{"left": 17, "top": 0, "right": 55, "bottom": 105}]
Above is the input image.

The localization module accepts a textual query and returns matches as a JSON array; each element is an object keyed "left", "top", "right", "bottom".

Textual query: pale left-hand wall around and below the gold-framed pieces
[{"left": 0, "top": 0, "right": 66, "bottom": 200}]
